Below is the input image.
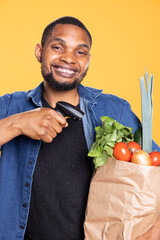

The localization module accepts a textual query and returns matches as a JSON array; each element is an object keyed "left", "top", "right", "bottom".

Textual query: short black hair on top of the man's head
[{"left": 41, "top": 16, "right": 92, "bottom": 48}]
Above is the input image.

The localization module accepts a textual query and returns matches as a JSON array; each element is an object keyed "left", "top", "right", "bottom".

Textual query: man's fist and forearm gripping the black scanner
[{"left": 0, "top": 108, "right": 68, "bottom": 145}]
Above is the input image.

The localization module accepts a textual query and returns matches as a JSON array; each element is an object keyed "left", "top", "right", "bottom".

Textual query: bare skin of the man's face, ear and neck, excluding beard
[{"left": 35, "top": 24, "right": 90, "bottom": 107}]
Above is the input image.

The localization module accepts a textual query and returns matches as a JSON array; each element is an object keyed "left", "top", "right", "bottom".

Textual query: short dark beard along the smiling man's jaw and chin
[{"left": 41, "top": 66, "right": 88, "bottom": 91}]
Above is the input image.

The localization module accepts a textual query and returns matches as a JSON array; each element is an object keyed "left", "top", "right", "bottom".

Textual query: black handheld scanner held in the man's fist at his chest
[{"left": 54, "top": 101, "right": 84, "bottom": 120}]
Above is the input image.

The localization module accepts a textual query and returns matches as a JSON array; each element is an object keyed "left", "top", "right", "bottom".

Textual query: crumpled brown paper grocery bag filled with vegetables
[{"left": 84, "top": 158, "right": 160, "bottom": 240}]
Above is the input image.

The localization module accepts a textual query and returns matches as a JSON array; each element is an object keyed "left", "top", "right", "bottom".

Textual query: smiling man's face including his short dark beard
[{"left": 37, "top": 24, "right": 90, "bottom": 90}]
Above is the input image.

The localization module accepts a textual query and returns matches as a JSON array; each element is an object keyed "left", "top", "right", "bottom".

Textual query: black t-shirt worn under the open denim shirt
[{"left": 24, "top": 99, "right": 92, "bottom": 240}]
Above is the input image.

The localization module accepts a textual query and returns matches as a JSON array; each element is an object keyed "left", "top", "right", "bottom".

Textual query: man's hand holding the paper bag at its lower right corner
[{"left": 136, "top": 216, "right": 160, "bottom": 240}]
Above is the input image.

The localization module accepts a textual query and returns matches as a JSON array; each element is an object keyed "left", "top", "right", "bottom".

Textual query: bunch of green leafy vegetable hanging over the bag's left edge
[{"left": 88, "top": 116, "right": 134, "bottom": 168}]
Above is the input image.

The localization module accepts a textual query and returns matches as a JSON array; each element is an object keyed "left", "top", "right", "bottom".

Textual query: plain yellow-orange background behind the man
[{"left": 0, "top": 0, "right": 160, "bottom": 145}]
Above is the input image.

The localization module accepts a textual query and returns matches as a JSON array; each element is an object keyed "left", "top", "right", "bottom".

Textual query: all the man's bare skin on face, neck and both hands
[{"left": 0, "top": 24, "right": 160, "bottom": 240}]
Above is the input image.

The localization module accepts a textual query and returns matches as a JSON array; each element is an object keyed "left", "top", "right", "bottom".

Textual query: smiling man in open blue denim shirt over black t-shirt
[{"left": 0, "top": 17, "right": 159, "bottom": 240}]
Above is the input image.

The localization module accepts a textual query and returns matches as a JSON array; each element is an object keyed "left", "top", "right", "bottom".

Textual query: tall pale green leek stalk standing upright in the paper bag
[{"left": 140, "top": 71, "right": 153, "bottom": 153}]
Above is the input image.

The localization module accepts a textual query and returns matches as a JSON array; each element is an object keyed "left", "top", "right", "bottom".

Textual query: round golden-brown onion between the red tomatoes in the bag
[{"left": 131, "top": 150, "right": 151, "bottom": 166}]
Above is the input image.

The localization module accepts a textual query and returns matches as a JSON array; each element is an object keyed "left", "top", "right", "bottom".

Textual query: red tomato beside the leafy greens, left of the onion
[{"left": 113, "top": 142, "right": 132, "bottom": 162}]
